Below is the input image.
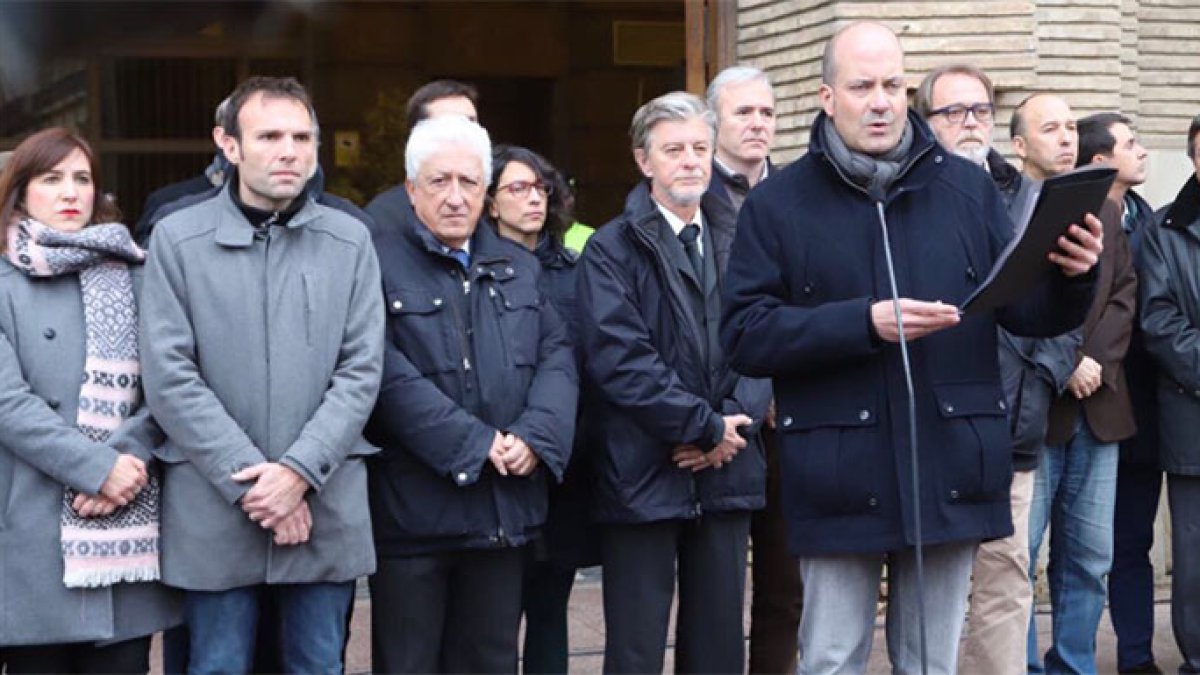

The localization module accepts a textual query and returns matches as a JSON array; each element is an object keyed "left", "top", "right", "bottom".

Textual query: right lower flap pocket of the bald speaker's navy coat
[{"left": 926, "top": 382, "right": 1013, "bottom": 502}]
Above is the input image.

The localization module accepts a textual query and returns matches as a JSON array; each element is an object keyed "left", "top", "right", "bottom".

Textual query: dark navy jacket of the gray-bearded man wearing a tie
[{"left": 578, "top": 181, "right": 770, "bottom": 522}]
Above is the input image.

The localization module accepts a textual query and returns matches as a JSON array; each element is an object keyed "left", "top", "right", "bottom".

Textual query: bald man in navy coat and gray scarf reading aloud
[{"left": 721, "top": 23, "right": 1100, "bottom": 674}]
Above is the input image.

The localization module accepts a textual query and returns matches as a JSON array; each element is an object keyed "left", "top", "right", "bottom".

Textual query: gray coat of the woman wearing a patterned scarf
[{"left": 0, "top": 261, "right": 181, "bottom": 646}]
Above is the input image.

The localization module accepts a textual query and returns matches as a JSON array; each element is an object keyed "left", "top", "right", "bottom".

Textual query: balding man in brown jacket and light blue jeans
[{"left": 1013, "top": 94, "right": 1136, "bottom": 673}]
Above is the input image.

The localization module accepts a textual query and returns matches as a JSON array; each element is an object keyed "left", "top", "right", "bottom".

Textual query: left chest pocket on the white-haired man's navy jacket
[{"left": 385, "top": 288, "right": 458, "bottom": 375}]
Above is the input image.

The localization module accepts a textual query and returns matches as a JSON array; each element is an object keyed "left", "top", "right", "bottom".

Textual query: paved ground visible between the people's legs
[{"left": 336, "top": 571, "right": 1180, "bottom": 675}]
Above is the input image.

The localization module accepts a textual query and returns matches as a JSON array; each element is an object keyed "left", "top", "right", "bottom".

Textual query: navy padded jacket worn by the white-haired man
[{"left": 366, "top": 215, "right": 578, "bottom": 556}]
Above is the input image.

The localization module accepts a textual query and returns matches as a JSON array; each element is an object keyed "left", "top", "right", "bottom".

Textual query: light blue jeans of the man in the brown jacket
[{"left": 1026, "top": 416, "right": 1118, "bottom": 673}]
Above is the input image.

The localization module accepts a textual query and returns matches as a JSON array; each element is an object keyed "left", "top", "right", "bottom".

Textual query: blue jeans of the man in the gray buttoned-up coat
[{"left": 185, "top": 581, "right": 354, "bottom": 674}]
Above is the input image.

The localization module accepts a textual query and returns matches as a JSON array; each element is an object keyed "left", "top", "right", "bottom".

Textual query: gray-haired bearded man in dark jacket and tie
[{"left": 578, "top": 91, "right": 770, "bottom": 673}]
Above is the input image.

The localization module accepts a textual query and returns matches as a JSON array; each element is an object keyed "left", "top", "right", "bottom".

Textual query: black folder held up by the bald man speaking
[{"left": 961, "top": 166, "right": 1117, "bottom": 313}]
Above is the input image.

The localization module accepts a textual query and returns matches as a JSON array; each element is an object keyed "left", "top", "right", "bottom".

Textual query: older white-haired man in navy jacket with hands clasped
[{"left": 367, "top": 115, "right": 578, "bottom": 673}]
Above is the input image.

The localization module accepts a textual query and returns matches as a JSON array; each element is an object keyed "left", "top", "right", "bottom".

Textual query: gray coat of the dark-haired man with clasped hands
[{"left": 140, "top": 189, "right": 384, "bottom": 591}]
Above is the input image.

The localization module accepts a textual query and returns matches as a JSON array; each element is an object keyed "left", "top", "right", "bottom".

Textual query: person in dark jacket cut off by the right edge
[{"left": 1138, "top": 115, "right": 1200, "bottom": 673}]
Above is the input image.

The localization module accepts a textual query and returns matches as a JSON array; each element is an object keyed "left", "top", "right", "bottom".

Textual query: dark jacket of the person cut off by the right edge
[{"left": 1138, "top": 177, "right": 1200, "bottom": 476}]
